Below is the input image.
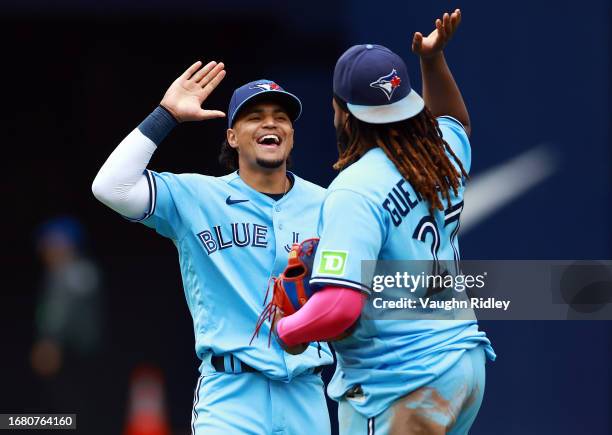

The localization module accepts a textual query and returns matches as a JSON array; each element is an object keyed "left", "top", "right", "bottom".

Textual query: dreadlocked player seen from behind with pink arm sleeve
[{"left": 276, "top": 10, "right": 495, "bottom": 434}]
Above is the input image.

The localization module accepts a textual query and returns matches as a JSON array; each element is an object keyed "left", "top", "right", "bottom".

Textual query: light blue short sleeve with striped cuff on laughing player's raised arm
[{"left": 138, "top": 169, "right": 183, "bottom": 240}]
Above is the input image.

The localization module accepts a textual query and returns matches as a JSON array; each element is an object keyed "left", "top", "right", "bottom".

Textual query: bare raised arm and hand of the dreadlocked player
[{"left": 412, "top": 9, "right": 471, "bottom": 136}]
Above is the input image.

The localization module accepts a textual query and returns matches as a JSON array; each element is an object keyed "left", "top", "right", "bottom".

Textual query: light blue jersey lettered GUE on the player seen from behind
[{"left": 310, "top": 117, "right": 495, "bottom": 417}]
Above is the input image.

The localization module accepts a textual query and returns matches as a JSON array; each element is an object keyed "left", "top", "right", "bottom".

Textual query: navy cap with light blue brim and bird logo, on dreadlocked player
[{"left": 334, "top": 44, "right": 425, "bottom": 124}]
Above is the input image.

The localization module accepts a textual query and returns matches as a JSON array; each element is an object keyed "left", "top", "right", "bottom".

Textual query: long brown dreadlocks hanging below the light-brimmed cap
[{"left": 334, "top": 96, "right": 469, "bottom": 215}]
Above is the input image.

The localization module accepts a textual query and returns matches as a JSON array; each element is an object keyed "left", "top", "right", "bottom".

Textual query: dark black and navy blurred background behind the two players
[{"left": 0, "top": 0, "right": 612, "bottom": 434}]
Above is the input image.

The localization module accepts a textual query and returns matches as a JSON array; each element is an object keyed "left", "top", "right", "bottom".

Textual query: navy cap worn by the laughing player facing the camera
[{"left": 228, "top": 79, "right": 302, "bottom": 128}]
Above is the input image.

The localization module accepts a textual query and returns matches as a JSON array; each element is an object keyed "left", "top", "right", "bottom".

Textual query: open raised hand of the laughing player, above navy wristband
[{"left": 160, "top": 61, "right": 225, "bottom": 122}]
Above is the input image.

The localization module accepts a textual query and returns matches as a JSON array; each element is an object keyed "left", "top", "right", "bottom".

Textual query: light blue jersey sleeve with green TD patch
[{"left": 310, "top": 190, "right": 386, "bottom": 294}]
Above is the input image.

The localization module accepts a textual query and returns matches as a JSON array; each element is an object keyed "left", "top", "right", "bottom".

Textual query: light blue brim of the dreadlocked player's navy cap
[{"left": 347, "top": 90, "right": 425, "bottom": 124}]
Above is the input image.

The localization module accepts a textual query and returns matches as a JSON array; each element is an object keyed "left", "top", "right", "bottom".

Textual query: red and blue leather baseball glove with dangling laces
[{"left": 251, "top": 238, "right": 319, "bottom": 354}]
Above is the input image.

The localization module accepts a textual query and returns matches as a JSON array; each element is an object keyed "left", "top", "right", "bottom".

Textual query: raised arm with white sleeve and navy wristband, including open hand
[{"left": 91, "top": 61, "right": 225, "bottom": 219}]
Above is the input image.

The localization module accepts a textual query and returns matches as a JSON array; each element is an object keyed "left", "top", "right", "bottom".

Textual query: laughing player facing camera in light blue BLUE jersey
[{"left": 92, "top": 62, "right": 332, "bottom": 435}]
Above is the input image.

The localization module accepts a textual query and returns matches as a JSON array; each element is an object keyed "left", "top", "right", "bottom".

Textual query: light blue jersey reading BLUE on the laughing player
[{"left": 136, "top": 171, "right": 332, "bottom": 380}]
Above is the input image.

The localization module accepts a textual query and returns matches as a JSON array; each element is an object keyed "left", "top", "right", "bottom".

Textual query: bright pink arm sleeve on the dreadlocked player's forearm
[{"left": 276, "top": 287, "right": 366, "bottom": 346}]
